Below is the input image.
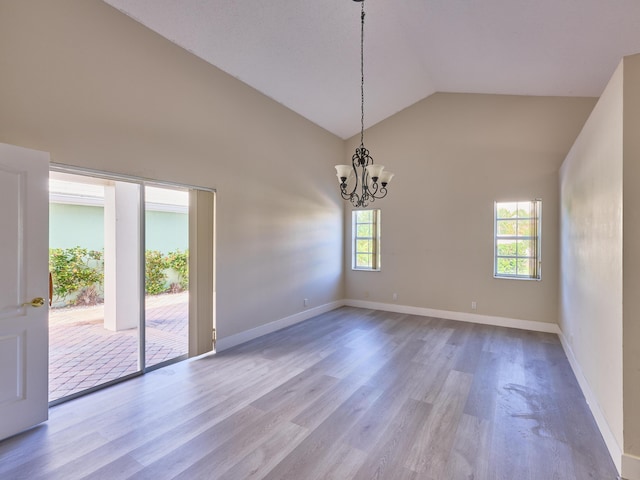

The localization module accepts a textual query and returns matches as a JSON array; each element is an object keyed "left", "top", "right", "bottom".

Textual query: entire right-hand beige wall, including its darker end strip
[{"left": 560, "top": 55, "right": 640, "bottom": 470}]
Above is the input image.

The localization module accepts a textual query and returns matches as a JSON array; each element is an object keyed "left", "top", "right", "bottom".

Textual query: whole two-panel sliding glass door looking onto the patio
[{"left": 49, "top": 171, "right": 200, "bottom": 403}]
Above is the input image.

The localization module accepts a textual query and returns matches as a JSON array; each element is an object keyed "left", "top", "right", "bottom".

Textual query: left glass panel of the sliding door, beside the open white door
[{"left": 49, "top": 172, "right": 141, "bottom": 402}]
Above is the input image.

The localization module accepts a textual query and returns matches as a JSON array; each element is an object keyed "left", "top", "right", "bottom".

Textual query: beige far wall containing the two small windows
[{"left": 345, "top": 94, "right": 595, "bottom": 322}]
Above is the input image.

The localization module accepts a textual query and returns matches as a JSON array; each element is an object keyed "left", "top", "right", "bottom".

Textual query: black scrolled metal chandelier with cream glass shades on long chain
[{"left": 336, "top": 0, "right": 393, "bottom": 208}]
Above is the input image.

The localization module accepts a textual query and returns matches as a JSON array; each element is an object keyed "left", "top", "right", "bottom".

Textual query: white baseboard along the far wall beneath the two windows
[{"left": 344, "top": 300, "right": 560, "bottom": 334}]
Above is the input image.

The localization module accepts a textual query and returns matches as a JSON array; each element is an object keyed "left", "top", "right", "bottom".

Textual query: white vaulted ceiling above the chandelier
[{"left": 104, "top": 0, "right": 640, "bottom": 138}]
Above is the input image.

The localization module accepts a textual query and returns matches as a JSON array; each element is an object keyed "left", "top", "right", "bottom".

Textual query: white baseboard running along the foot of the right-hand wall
[{"left": 558, "top": 331, "right": 624, "bottom": 480}]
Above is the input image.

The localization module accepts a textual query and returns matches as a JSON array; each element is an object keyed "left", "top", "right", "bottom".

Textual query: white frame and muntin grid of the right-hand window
[{"left": 493, "top": 198, "right": 542, "bottom": 281}]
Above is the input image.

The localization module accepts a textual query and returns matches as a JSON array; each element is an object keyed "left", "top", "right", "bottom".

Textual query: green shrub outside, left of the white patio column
[{"left": 49, "top": 247, "right": 104, "bottom": 298}]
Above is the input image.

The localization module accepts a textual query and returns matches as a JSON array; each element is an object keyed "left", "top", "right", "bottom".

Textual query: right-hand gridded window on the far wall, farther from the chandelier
[{"left": 494, "top": 199, "right": 542, "bottom": 280}]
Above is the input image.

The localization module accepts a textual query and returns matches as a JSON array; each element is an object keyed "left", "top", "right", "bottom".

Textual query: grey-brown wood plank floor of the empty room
[{"left": 0, "top": 307, "right": 617, "bottom": 480}]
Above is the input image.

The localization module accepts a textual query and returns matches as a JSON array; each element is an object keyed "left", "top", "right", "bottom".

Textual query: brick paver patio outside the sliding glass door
[{"left": 49, "top": 292, "right": 189, "bottom": 401}]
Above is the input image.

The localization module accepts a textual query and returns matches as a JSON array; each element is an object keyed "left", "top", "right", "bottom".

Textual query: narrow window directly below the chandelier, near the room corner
[{"left": 352, "top": 210, "right": 380, "bottom": 270}]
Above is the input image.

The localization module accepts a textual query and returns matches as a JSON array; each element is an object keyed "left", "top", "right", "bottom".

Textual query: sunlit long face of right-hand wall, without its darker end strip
[{"left": 559, "top": 61, "right": 623, "bottom": 449}]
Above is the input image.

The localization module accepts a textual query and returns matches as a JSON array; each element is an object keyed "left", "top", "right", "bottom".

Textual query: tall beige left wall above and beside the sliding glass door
[{"left": 0, "top": 0, "right": 344, "bottom": 338}]
